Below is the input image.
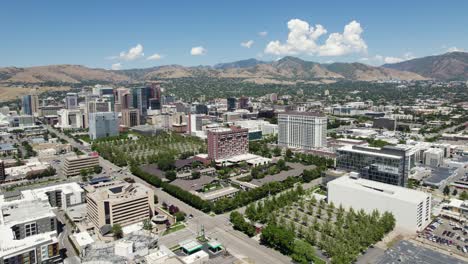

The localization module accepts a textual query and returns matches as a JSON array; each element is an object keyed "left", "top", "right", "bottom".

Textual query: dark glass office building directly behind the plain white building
[{"left": 336, "top": 145, "right": 416, "bottom": 186}]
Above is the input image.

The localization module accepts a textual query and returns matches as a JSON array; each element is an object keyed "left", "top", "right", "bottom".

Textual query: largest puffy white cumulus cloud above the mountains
[{"left": 265, "top": 19, "right": 367, "bottom": 56}]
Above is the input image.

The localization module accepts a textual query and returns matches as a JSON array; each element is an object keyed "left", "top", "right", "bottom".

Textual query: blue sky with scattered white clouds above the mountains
[{"left": 0, "top": 0, "right": 468, "bottom": 69}]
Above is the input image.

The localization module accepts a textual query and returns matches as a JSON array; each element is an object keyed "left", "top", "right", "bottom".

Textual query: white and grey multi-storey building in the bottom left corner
[{"left": 0, "top": 200, "right": 61, "bottom": 264}]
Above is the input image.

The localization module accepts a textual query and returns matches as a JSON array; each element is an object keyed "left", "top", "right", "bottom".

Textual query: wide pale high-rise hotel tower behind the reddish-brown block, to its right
[{"left": 278, "top": 112, "right": 327, "bottom": 150}]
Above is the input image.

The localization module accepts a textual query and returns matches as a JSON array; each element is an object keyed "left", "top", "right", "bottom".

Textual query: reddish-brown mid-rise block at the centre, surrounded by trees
[{"left": 208, "top": 127, "right": 249, "bottom": 160}]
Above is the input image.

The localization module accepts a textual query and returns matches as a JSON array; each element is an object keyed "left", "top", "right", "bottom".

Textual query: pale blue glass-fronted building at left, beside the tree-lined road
[{"left": 89, "top": 112, "right": 119, "bottom": 140}]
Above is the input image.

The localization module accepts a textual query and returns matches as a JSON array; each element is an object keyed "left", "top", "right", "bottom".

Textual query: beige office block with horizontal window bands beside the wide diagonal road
[{"left": 85, "top": 181, "right": 154, "bottom": 229}]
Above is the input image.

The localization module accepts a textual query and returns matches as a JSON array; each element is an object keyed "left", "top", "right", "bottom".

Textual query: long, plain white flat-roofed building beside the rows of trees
[{"left": 327, "top": 176, "right": 431, "bottom": 232}]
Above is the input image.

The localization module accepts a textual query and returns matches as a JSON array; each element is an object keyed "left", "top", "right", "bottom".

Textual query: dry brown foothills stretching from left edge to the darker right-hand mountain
[{"left": 0, "top": 57, "right": 424, "bottom": 84}]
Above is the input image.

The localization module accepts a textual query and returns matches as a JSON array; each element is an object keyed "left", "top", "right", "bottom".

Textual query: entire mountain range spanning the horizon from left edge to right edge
[{"left": 0, "top": 52, "right": 468, "bottom": 84}]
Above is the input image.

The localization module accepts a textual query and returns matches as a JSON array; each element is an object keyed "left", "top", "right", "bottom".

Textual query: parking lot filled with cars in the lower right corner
[{"left": 420, "top": 214, "right": 468, "bottom": 256}]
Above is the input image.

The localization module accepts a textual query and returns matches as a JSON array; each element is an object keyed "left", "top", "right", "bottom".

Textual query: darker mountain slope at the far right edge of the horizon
[{"left": 382, "top": 52, "right": 468, "bottom": 81}]
